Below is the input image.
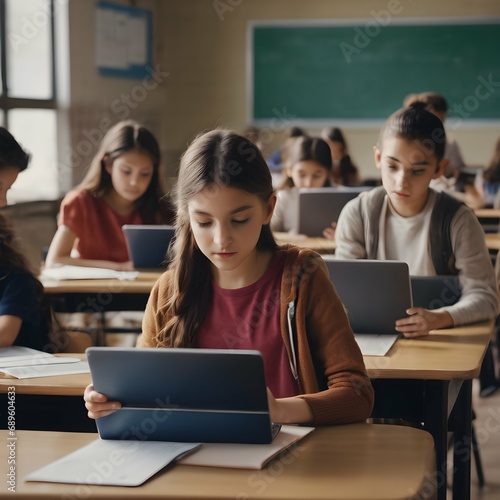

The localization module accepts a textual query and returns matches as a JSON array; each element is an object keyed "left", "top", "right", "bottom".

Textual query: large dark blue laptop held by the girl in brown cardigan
[{"left": 86, "top": 347, "right": 280, "bottom": 444}]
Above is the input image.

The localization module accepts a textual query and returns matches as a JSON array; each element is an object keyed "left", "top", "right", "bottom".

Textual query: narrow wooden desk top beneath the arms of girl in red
[{"left": 41, "top": 271, "right": 161, "bottom": 294}]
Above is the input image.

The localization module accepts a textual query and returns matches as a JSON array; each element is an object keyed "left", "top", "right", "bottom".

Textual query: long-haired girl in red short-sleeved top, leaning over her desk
[{"left": 46, "top": 121, "right": 173, "bottom": 271}]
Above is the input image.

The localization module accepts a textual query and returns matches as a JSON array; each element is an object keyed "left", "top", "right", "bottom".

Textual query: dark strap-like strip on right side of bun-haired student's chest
[{"left": 429, "top": 191, "right": 463, "bottom": 275}]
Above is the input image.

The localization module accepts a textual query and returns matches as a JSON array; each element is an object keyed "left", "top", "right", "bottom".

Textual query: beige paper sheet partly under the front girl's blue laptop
[{"left": 178, "top": 425, "right": 314, "bottom": 469}]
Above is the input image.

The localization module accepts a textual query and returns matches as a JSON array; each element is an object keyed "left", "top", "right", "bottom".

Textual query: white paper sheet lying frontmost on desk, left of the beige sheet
[{"left": 25, "top": 439, "right": 201, "bottom": 486}]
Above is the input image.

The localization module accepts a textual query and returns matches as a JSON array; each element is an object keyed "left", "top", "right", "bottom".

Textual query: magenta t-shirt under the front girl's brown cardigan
[{"left": 197, "top": 252, "right": 299, "bottom": 398}]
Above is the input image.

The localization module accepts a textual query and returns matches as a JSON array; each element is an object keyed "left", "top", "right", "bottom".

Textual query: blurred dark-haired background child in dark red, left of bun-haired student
[{"left": 321, "top": 127, "right": 360, "bottom": 186}]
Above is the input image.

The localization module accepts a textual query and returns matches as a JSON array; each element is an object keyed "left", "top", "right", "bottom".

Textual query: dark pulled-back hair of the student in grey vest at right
[{"left": 378, "top": 101, "right": 446, "bottom": 163}]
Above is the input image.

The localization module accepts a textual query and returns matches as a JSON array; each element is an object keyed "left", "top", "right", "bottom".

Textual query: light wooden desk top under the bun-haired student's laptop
[{"left": 364, "top": 322, "right": 493, "bottom": 380}]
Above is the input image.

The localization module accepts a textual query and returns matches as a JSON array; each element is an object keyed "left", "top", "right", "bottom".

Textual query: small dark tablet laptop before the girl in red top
[{"left": 122, "top": 224, "right": 175, "bottom": 269}]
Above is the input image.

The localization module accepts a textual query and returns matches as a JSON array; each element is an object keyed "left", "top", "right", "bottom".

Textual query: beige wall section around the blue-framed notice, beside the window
[{"left": 67, "top": 0, "right": 167, "bottom": 185}]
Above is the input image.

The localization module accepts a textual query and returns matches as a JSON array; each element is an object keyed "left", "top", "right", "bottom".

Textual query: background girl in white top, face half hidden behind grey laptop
[{"left": 271, "top": 137, "right": 332, "bottom": 232}]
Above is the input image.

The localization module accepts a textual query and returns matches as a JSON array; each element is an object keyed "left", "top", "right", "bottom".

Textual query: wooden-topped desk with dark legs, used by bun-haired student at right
[{"left": 364, "top": 322, "right": 493, "bottom": 500}]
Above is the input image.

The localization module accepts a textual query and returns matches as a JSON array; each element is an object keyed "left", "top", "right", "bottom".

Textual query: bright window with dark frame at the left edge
[{"left": 0, "top": 0, "right": 59, "bottom": 203}]
